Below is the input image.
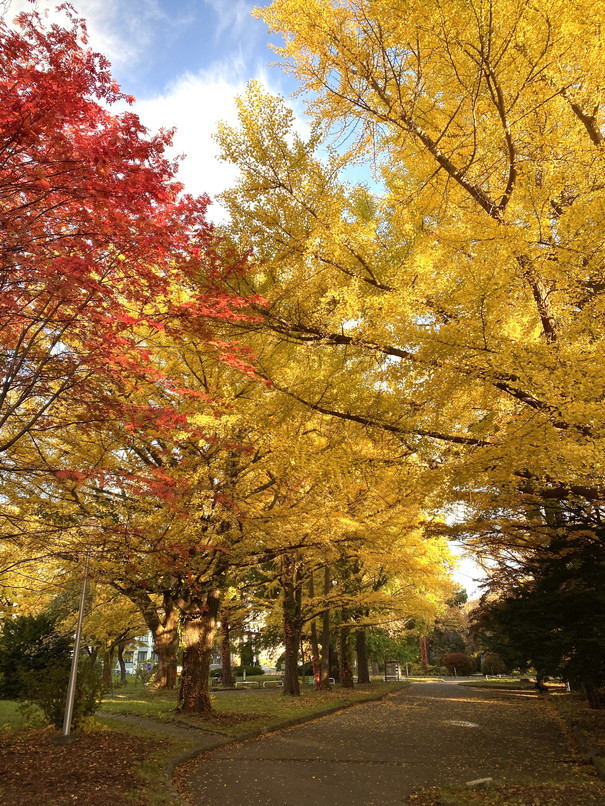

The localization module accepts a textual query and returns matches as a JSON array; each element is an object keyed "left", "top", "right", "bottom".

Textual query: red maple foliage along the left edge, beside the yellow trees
[{"left": 0, "top": 5, "right": 250, "bottom": 460}]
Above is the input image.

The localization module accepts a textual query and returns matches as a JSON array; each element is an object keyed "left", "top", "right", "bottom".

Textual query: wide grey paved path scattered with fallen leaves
[{"left": 186, "top": 683, "right": 577, "bottom": 806}]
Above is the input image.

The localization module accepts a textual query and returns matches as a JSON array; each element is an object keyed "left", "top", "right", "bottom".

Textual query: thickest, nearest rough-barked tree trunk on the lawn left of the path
[{"left": 177, "top": 590, "right": 220, "bottom": 714}]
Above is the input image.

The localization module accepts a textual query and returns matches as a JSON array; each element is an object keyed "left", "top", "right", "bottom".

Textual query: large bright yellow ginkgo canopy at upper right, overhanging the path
[{"left": 218, "top": 0, "right": 605, "bottom": 560}]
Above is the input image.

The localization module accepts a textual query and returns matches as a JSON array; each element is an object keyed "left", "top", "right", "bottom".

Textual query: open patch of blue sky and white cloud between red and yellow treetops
[{"left": 7, "top": 0, "right": 304, "bottom": 221}]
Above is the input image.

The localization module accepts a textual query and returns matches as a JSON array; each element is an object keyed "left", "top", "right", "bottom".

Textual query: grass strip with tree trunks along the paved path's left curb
[{"left": 100, "top": 682, "right": 406, "bottom": 738}]
